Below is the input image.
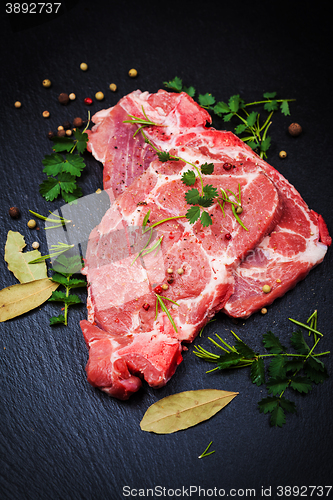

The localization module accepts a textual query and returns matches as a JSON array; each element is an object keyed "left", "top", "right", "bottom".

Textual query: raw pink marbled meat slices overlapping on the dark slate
[{"left": 81, "top": 90, "right": 330, "bottom": 399}]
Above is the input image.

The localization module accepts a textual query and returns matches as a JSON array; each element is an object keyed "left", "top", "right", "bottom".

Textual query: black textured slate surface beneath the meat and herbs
[{"left": 0, "top": 0, "right": 333, "bottom": 500}]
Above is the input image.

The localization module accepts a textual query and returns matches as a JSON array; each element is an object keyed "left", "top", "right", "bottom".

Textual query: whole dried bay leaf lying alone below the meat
[{"left": 140, "top": 389, "right": 238, "bottom": 434}]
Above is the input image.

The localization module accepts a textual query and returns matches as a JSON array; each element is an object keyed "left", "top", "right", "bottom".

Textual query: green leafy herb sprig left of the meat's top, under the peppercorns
[{"left": 39, "top": 118, "right": 90, "bottom": 203}]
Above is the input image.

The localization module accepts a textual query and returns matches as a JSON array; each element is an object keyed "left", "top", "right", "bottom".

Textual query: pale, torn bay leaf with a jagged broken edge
[{"left": 5, "top": 231, "right": 47, "bottom": 283}]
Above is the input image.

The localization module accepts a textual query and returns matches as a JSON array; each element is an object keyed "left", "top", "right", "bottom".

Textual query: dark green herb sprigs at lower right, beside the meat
[{"left": 194, "top": 311, "right": 330, "bottom": 427}]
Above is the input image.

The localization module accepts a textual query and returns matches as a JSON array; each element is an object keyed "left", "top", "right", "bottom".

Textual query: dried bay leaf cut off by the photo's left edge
[{"left": 0, "top": 278, "right": 59, "bottom": 322}]
